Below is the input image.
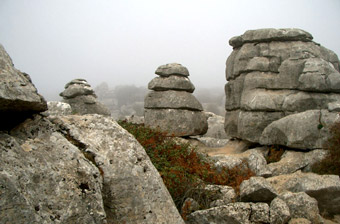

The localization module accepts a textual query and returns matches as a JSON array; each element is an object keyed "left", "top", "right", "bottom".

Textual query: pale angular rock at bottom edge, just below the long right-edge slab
[{"left": 279, "top": 192, "right": 323, "bottom": 224}]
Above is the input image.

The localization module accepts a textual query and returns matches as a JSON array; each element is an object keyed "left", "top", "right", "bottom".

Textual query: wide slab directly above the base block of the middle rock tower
[{"left": 144, "top": 90, "right": 203, "bottom": 111}]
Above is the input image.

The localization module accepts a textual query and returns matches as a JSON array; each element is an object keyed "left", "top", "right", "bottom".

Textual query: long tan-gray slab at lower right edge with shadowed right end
[{"left": 267, "top": 171, "right": 340, "bottom": 215}]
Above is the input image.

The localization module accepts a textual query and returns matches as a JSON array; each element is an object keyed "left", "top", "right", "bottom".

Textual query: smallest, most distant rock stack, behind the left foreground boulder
[{"left": 60, "top": 79, "right": 111, "bottom": 115}]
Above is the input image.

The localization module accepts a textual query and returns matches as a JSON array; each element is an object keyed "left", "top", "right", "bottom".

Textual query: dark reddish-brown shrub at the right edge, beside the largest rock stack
[{"left": 312, "top": 122, "right": 340, "bottom": 176}]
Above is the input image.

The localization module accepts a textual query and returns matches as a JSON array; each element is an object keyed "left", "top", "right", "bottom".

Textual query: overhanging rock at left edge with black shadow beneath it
[{"left": 0, "top": 44, "right": 47, "bottom": 129}]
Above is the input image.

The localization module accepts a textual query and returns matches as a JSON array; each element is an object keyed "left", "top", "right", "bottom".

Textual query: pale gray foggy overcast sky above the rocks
[{"left": 0, "top": 0, "right": 340, "bottom": 99}]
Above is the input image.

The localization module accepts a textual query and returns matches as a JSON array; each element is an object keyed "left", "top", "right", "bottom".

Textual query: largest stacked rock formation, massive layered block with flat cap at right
[{"left": 225, "top": 29, "right": 340, "bottom": 149}]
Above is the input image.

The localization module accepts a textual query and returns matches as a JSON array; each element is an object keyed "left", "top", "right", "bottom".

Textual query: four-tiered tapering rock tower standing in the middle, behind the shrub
[{"left": 144, "top": 63, "right": 208, "bottom": 136}]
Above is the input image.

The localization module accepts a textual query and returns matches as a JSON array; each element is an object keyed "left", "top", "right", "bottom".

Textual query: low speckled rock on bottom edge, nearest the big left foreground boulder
[{"left": 186, "top": 202, "right": 251, "bottom": 224}]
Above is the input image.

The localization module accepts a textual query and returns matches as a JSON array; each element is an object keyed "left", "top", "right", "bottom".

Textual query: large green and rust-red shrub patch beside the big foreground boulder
[{"left": 118, "top": 121, "right": 254, "bottom": 211}]
